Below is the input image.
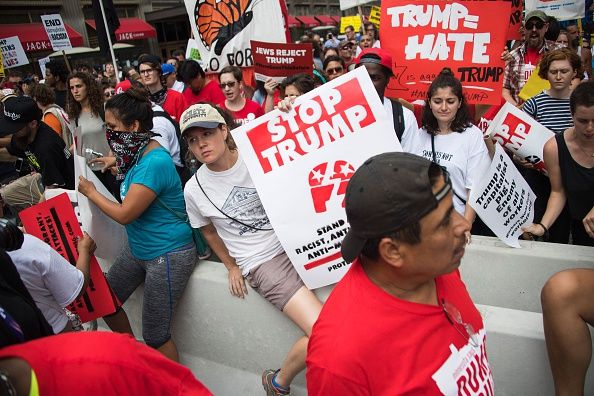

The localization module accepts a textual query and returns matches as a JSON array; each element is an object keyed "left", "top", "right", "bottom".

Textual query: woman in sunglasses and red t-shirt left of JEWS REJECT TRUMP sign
[{"left": 219, "top": 66, "right": 264, "bottom": 125}]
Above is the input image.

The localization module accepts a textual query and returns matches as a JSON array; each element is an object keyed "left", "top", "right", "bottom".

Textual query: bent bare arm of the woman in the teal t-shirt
[{"left": 78, "top": 176, "right": 157, "bottom": 225}]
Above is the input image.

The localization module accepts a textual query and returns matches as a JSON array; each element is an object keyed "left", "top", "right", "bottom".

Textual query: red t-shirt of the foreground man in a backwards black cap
[{"left": 306, "top": 260, "right": 493, "bottom": 396}]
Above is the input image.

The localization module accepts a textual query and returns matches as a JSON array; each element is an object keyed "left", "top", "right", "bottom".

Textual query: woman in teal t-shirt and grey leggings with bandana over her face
[{"left": 78, "top": 88, "right": 197, "bottom": 361}]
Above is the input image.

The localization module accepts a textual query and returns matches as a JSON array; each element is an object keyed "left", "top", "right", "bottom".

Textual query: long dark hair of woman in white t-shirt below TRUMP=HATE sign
[{"left": 421, "top": 67, "right": 472, "bottom": 135}]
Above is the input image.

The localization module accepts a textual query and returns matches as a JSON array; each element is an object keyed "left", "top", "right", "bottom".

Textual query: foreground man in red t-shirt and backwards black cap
[{"left": 307, "top": 153, "right": 493, "bottom": 396}]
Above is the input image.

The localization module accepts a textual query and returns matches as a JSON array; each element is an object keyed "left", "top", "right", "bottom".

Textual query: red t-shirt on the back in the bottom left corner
[{"left": 0, "top": 331, "right": 212, "bottom": 396}]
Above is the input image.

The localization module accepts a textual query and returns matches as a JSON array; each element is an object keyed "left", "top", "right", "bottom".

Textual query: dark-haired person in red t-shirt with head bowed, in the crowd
[{"left": 177, "top": 60, "right": 225, "bottom": 107}]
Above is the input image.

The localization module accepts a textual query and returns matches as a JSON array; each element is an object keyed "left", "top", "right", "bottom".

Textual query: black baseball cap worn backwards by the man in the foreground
[{"left": 341, "top": 152, "right": 452, "bottom": 262}]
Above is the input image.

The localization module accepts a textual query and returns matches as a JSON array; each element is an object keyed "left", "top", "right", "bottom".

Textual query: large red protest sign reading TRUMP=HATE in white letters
[{"left": 380, "top": 0, "right": 510, "bottom": 104}]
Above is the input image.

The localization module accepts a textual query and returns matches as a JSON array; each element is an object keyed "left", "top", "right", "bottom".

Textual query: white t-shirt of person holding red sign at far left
[{"left": 7, "top": 234, "right": 84, "bottom": 333}]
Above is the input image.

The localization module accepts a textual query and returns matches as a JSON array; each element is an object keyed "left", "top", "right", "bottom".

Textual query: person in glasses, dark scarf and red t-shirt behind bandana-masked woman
[{"left": 138, "top": 55, "right": 187, "bottom": 122}]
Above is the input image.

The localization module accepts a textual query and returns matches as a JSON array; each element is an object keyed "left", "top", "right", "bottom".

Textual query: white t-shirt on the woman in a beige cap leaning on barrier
[{"left": 184, "top": 155, "right": 283, "bottom": 276}]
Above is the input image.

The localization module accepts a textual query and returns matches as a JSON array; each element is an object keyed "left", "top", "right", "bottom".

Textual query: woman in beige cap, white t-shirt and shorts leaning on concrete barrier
[{"left": 181, "top": 104, "right": 322, "bottom": 395}]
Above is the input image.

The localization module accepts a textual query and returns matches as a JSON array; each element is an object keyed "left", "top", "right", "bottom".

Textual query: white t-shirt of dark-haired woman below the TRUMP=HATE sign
[{"left": 402, "top": 125, "right": 490, "bottom": 215}]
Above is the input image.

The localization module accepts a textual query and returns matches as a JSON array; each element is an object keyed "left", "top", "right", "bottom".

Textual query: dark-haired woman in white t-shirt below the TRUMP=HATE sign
[{"left": 402, "top": 68, "right": 490, "bottom": 237}]
